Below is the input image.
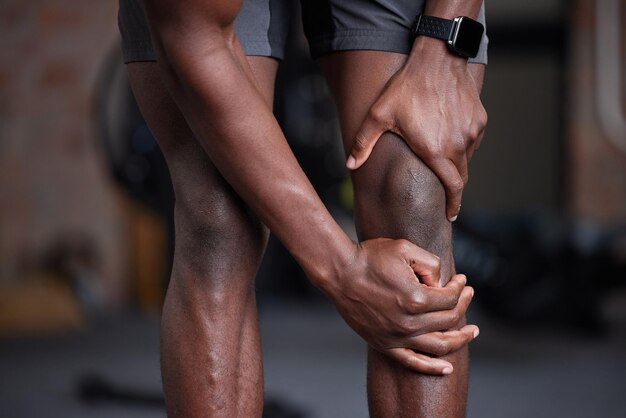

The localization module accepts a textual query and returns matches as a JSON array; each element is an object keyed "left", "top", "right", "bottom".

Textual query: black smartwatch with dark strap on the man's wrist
[{"left": 413, "top": 15, "right": 485, "bottom": 58}]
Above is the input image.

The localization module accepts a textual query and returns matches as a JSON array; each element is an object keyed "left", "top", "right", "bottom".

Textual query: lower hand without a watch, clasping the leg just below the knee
[{"left": 329, "top": 238, "right": 478, "bottom": 374}]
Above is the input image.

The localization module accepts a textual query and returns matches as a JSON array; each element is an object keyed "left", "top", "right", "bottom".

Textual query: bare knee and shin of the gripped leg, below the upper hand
[{"left": 354, "top": 134, "right": 467, "bottom": 417}]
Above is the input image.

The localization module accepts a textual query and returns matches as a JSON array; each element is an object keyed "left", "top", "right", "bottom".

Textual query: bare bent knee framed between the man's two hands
[{"left": 354, "top": 133, "right": 451, "bottom": 255}]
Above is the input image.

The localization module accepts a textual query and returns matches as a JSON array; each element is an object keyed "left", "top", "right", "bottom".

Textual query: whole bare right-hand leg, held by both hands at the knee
[{"left": 320, "top": 51, "right": 480, "bottom": 418}]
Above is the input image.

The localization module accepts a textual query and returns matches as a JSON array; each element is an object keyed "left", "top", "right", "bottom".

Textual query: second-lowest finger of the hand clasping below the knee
[{"left": 409, "top": 325, "right": 480, "bottom": 357}]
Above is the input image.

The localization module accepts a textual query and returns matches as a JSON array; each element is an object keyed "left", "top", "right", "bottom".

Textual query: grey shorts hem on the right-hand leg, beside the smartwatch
[{"left": 309, "top": 29, "right": 487, "bottom": 65}]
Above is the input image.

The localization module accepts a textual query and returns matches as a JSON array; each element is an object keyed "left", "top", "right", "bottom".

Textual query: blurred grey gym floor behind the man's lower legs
[{"left": 0, "top": 301, "right": 626, "bottom": 418}]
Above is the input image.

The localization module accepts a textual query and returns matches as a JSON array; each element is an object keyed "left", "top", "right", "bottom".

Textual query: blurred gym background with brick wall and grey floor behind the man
[{"left": 0, "top": 0, "right": 626, "bottom": 418}]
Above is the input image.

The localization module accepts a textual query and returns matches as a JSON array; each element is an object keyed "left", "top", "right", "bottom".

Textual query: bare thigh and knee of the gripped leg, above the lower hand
[{"left": 319, "top": 51, "right": 454, "bottom": 272}]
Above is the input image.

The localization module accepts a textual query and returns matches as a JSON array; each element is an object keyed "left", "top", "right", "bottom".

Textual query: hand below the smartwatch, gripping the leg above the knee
[{"left": 347, "top": 38, "right": 487, "bottom": 221}]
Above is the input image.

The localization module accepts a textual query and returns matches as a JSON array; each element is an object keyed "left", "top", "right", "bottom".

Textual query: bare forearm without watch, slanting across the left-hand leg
[{"left": 142, "top": 3, "right": 354, "bottom": 287}]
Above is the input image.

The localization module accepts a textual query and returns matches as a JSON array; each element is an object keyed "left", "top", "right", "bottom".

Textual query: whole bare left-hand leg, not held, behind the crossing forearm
[{"left": 128, "top": 58, "right": 277, "bottom": 418}]
